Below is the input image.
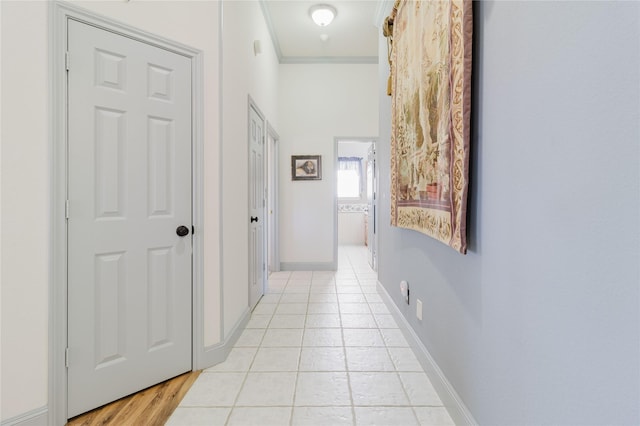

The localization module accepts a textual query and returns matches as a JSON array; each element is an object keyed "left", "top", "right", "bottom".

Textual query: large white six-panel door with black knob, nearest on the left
[{"left": 67, "top": 20, "right": 192, "bottom": 417}]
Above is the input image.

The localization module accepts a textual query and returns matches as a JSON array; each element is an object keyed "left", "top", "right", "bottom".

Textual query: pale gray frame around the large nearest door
[{"left": 48, "top": 1, "right": 205, "bottom": 424}]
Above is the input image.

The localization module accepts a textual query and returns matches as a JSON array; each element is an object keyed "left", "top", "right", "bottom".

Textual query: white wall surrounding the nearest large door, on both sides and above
[{"left": 0, "top": 0, "right": 220, "bottom": 420}]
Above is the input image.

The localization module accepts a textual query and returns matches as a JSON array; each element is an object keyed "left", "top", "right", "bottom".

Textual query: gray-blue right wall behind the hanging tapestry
[{"left": 378, "top": 1, "right": 640, "bottom": 425}]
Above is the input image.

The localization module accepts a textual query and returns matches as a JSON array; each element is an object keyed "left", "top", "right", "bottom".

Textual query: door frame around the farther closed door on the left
[{"left": 247, "top": 95, "right": 268, "bottom": 309}]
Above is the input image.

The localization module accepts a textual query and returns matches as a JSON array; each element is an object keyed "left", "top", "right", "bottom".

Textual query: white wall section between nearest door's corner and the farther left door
[{"left": 222, "top": 1, "right": 279, "bottom": 334}]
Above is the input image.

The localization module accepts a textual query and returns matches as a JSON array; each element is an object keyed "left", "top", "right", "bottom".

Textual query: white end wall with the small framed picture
[{"left": 279, "top": 64, "right": 378, "bottom": 267}]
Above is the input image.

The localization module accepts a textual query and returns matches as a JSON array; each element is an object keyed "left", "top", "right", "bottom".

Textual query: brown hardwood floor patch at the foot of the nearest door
[{"left": 67, "top": 371, "right": 200, "bottom": 426}]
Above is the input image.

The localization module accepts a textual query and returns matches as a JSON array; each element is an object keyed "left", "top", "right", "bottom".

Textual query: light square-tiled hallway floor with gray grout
[{"left": 167, "top": 247, "right": 453, "bottom": 426}]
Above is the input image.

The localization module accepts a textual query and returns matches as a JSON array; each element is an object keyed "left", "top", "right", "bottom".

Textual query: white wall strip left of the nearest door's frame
[{"left": 0, "top": 2, "right": 57, "bottom": 419}]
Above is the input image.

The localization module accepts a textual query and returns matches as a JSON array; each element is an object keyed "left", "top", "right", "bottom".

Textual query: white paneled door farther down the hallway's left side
[{"left": 249, "top": 106, "right": 266, "bottom": 309}]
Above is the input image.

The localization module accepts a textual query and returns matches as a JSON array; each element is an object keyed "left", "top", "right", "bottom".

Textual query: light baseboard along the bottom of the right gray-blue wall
[{"left": 378, "top": 281, "right": 478, "bottom": 425}]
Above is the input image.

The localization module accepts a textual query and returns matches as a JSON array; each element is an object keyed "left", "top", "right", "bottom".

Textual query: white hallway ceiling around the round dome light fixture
[{"left": 261, "top": 0, "right": 384, "bottom": 63}]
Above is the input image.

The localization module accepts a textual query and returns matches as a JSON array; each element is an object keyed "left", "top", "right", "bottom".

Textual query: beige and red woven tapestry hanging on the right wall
[{"left": 384, "top": 0, "right": 473, "bottom": 254}]
